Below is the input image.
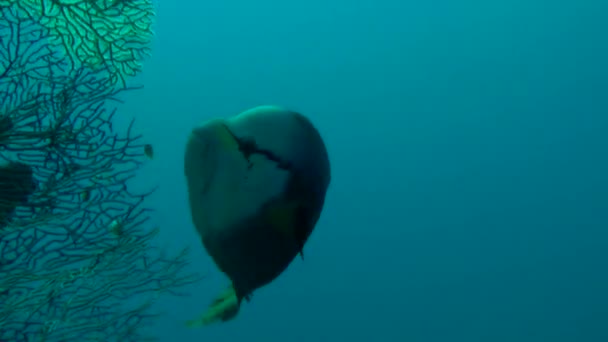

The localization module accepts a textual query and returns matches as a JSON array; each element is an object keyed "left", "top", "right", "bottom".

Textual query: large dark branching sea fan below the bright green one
[{"left": 0, "top": 0, "right": 199, "bottom": 342}]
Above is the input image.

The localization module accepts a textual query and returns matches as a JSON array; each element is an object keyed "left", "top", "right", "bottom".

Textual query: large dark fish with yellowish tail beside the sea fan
[{"left": 184, "top": 106, "right": 331, "bottom": 327}]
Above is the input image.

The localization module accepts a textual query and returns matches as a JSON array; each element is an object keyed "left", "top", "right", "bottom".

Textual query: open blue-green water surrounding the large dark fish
[{"left": 120, "top": 0, "right": 608, "bottom": 342}]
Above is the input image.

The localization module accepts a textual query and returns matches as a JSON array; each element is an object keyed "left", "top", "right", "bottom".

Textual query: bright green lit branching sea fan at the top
[{"left": 0, "top": 0, "right": 154, "bottom": 84}]
